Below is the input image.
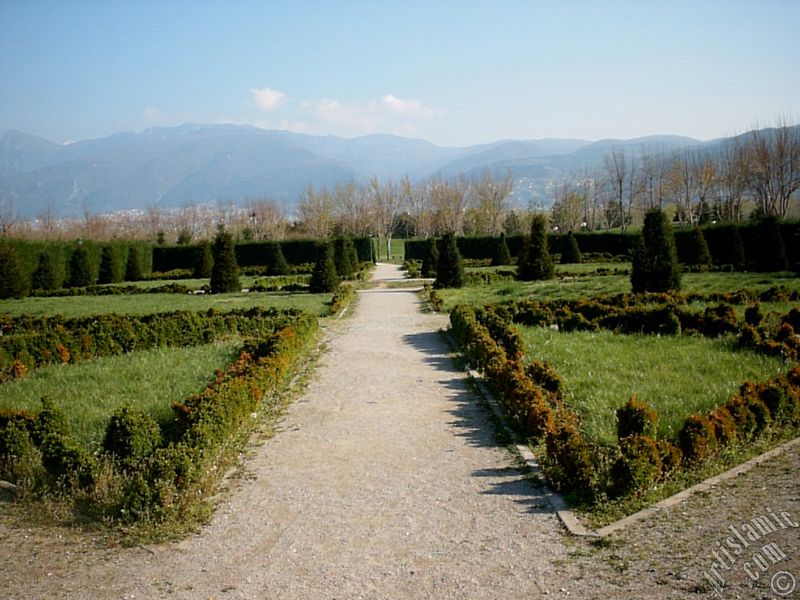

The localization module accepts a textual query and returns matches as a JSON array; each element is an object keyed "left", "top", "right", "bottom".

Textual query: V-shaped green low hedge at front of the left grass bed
[{"left": 0, "top": 313, "right": 318, "bottom": 523}]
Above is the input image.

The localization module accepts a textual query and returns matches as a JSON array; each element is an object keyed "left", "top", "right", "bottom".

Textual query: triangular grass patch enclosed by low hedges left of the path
[{"left": 0, "top": 339, "right": 241, "bottom": 448}]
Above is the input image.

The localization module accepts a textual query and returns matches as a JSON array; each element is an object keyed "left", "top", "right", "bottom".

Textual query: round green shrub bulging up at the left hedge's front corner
[{"left": 103, "top": 405, "right": 161, "bottom": 468}]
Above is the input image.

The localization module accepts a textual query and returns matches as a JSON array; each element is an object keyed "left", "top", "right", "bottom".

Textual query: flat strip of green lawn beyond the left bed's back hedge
[{"left": 0, "top": 292, "right": 331, "bottom": 317}]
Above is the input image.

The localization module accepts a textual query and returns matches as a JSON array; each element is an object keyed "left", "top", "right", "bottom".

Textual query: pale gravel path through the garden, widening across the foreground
[{"left": 0, "top": 265, "right": 800, "bottom": 599}]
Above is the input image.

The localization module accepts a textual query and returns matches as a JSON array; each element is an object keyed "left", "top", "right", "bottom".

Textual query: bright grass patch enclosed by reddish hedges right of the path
[{"left": 519, "top": 327, "right": 786, "bottom": 443}]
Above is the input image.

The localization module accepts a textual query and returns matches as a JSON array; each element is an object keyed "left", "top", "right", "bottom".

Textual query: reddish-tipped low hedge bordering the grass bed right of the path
[{"left": 450, "top": 301, "right": 800, "bottom": 501}]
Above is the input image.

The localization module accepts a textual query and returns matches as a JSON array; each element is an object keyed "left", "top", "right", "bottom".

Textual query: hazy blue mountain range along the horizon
[{"left": 0, "top": 124, "right": 713, "bottom": 218}]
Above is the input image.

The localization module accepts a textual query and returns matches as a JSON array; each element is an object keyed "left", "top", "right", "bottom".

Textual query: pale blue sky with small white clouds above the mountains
[{"left": 0, "top": 0, "right": 800, "bottom": 146}]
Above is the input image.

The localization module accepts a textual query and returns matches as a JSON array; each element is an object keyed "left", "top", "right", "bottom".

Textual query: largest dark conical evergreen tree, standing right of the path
[{"left": 631, "top": 208, "right": 681, "bottom": 294}]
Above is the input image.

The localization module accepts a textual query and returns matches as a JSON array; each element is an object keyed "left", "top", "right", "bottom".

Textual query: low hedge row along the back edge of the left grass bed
[{"left": 0, "top": 308, "right": 300, "bottom": 382}]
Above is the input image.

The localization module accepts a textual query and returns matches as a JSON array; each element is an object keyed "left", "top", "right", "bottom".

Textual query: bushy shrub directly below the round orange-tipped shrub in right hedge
[{"left": 609, "top": 435, "right": 663, "bottom": 497}]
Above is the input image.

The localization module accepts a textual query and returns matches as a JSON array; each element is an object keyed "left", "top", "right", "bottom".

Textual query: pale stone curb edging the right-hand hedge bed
[{"left": 462, "top": 356, "right": 800, "bottom": 537}]
